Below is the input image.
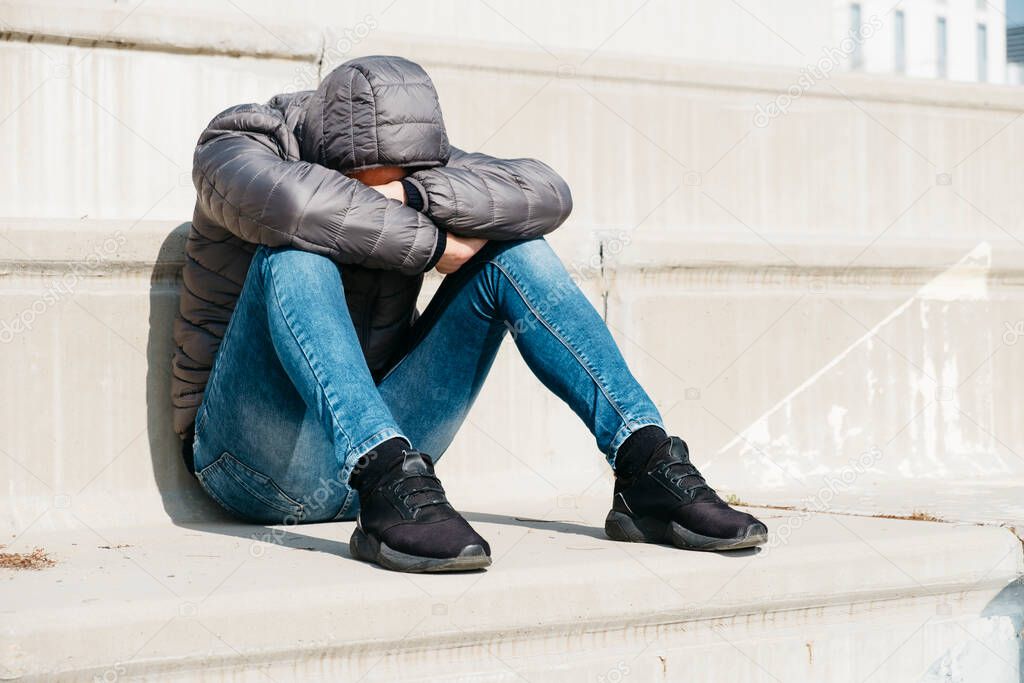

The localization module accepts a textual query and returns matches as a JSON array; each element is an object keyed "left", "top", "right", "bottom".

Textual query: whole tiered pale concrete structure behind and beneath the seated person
[{"left": 0, "top": 0, "right": 1024, "bottom": 683}]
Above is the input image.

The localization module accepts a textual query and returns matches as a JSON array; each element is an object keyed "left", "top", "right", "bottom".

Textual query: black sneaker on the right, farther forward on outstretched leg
[{"left": 604, "top": 436, "right": 768, "bottom": 550}]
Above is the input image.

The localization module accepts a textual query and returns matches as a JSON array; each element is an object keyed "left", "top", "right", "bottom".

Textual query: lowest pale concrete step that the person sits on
[{"left": 0, "top": 497, "right": 1024, "bottom": 683}]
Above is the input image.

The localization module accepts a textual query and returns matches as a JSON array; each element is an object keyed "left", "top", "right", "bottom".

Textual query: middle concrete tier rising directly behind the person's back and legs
[{"left": 6, "top": 219, "right": 1024, "bottom": 532}]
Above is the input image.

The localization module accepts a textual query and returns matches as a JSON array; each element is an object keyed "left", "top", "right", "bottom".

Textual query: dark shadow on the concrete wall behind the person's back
[{"left": 145, "top": 223, "right": 228, "bottom": 525}]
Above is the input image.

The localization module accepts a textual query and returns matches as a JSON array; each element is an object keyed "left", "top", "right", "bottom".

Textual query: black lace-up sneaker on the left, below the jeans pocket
[{"left": 348, "top": 451, "right": 490, "bottom": 571}]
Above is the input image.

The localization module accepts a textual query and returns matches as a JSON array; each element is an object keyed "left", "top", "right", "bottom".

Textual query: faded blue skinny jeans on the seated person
[{"left": 194, "top": 239, "right": 662, "bottom": 523}]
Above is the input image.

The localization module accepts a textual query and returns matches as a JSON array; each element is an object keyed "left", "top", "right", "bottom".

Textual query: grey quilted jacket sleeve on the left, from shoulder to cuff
[{"left": 193, "top": 104, "right": 438, "bottom": 274}]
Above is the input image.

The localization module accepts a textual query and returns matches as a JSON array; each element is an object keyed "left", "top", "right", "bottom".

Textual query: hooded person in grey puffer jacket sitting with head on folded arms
[{"left": 167, "top": 56, "right": 767, "bottom": 571}]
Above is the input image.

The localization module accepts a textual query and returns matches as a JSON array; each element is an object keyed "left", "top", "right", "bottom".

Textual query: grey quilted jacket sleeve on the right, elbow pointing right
[{"left": 411, "top": 147, "right": 572, "bottom": 240}]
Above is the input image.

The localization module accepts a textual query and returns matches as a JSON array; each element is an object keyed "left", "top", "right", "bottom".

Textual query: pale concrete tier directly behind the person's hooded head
[{"left": 0, "top": 10, "right": 1024, "bottom": 225}]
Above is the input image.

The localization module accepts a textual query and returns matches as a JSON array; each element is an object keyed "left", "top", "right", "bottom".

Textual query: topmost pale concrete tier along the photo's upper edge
[{"left": 4, "top": 0, "right": 835, "bottom": 72}]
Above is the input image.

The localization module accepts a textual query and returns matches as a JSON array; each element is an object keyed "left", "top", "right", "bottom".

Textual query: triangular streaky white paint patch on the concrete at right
[{"left": 718, "top": 242, "right": 992, "bottom": 485}]
